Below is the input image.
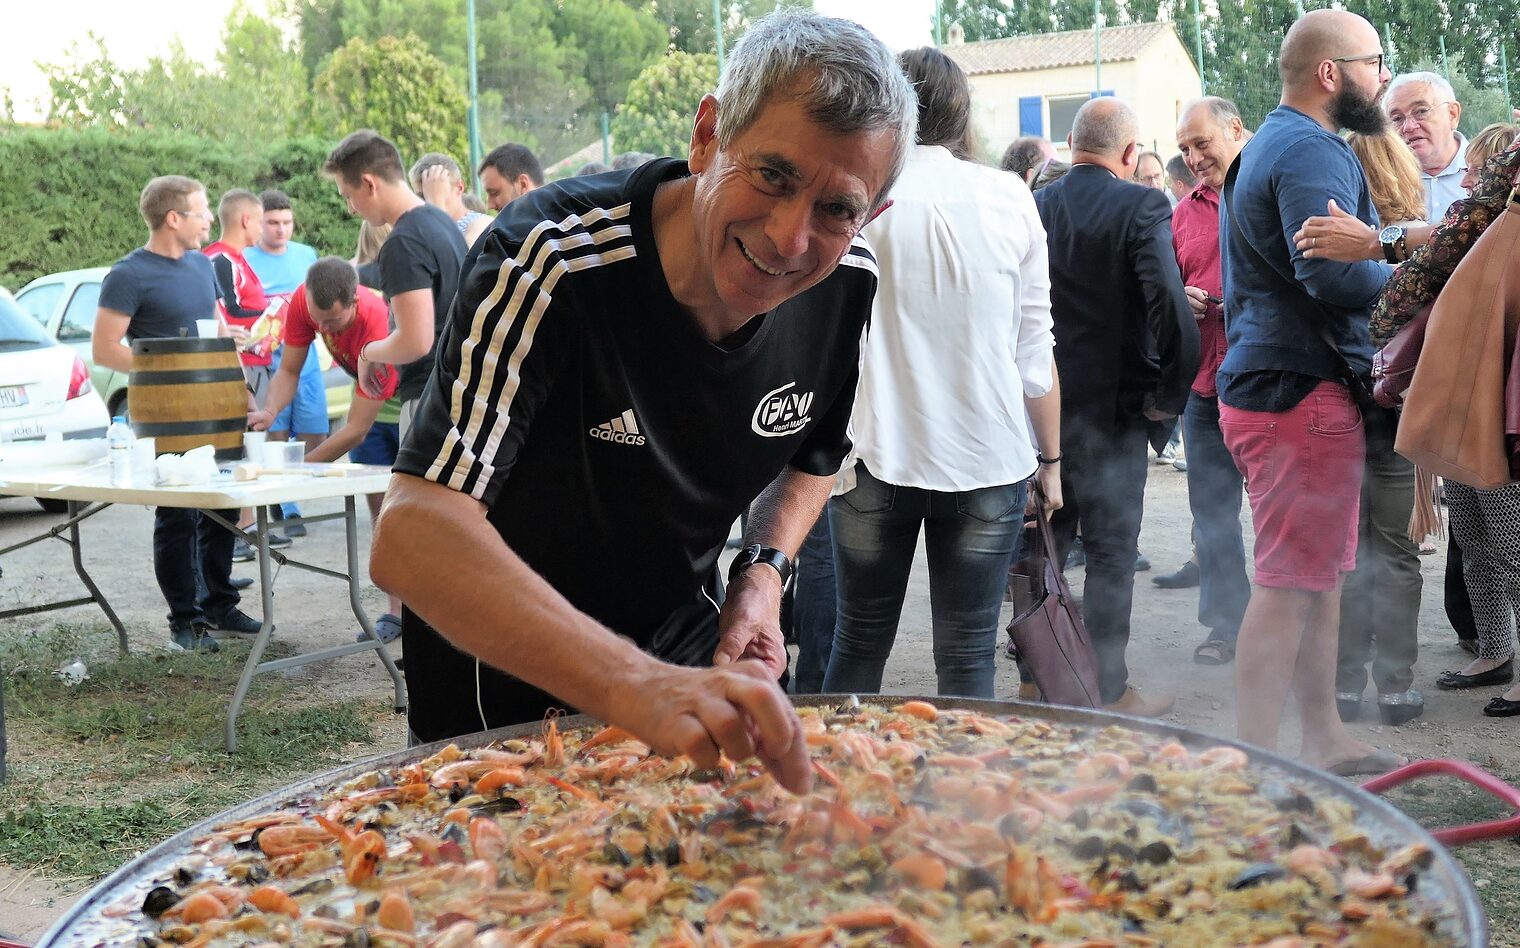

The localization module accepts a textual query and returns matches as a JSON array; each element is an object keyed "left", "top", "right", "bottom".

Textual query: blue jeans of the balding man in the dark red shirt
[{"left": 1183, "top": 392, "right": 1251, "bottom": 644}]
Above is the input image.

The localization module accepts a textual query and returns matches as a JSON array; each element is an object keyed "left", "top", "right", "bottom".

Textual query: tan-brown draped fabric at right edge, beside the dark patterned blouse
[{"left": 1394, "top": 185, "right": 1520, "bottom": 491}]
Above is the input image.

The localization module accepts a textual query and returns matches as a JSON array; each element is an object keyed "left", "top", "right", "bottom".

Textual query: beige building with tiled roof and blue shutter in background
[{"left": 941, "top": 23, "right": 1204, "bottom": 161}]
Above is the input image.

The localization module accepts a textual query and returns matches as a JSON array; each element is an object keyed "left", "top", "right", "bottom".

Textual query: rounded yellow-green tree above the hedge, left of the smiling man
[{"left": 312, "top": 35, "right": 467, "bottom": 161}]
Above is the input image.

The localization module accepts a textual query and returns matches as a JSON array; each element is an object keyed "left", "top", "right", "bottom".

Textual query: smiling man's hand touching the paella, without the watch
[{"left": 606, "top": 661, "right": 813, "bottom": 793}]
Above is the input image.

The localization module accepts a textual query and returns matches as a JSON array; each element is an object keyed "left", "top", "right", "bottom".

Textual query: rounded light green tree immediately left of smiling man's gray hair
[{"left": 613, "top": 52, "right": 717, "bottom": 155}]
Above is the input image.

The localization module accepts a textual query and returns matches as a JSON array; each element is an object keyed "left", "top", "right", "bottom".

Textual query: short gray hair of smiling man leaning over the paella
[{"left": 717, "top": 9, "right": 918, "bottom": 205}]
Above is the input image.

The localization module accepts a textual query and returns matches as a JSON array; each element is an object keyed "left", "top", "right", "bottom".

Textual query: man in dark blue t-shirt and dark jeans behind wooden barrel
[{"left": 91, "top": 175, "right": 258, "bottom": 652}]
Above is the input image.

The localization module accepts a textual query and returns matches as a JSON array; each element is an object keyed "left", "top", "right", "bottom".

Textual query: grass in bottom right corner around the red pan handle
[{"left": 1383, "top": 770, "right": 1520, "bottom": 945}]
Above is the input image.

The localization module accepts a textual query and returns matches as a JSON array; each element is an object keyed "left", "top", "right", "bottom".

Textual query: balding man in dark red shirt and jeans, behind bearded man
[{"left": 1157, "top": 96, "right": 1251, "bottom": 665}]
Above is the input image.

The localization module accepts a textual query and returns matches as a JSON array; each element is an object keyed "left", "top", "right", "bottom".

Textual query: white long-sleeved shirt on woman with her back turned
[{"left": 847, "top": 146, "right": 1055, "bottom": 491}]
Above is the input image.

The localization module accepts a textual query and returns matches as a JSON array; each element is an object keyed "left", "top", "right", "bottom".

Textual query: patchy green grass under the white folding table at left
[{"left": 0, "top": 624, "right": 389, "bottom": 881}]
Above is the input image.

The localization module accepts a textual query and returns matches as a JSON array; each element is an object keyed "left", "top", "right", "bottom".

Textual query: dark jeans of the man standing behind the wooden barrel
[{"left": 154, "top": 507, "right": 239, "bottom": 629}]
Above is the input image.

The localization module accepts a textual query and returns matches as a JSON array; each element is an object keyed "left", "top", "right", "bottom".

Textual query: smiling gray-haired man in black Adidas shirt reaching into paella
[{"left": 371, "top": 12, "right": 917, "bottom": 788}]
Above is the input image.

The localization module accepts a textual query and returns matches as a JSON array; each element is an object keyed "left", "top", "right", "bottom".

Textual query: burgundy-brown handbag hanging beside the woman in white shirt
[{"left": 1008, "top": 485, "right": 1102, "bottom": 708}]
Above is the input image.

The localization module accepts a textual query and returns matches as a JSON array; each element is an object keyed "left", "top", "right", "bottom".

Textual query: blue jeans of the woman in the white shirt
[{"left": 824, "top": 463, "right": 1024, "bottom": 697}]
